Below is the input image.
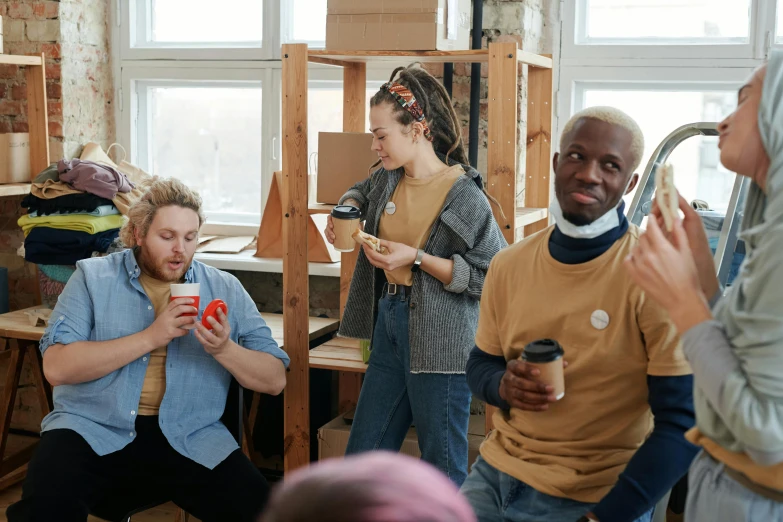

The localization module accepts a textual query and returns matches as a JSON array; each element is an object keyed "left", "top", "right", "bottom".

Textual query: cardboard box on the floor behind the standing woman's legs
[{"left": 318, "top": 415, "right": 484, "bottom": 470}]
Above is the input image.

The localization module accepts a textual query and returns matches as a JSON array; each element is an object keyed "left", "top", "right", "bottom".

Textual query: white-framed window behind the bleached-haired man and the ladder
[{"left": 555, "top": 0, "right": 783, "bottom": 217}]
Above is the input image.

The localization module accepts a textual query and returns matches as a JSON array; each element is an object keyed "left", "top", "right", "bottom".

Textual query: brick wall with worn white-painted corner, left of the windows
[{"left": 0, "top": 0, "right": 115, "bottom": 310}]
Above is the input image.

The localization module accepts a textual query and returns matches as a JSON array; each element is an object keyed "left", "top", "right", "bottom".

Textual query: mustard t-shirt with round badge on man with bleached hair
[{"left": 476, "top": 226, "right": 691, "bottom": 502}]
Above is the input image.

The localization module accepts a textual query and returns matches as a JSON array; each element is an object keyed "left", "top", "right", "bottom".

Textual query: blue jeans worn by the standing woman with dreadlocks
[{"left": 346, "top": 295, "right": 470, "bottom": 486}]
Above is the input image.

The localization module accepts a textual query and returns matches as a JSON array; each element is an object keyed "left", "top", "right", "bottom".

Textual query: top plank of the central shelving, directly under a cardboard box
[{"left": 307, "top": 49, "right": 490, "bottom": 65}]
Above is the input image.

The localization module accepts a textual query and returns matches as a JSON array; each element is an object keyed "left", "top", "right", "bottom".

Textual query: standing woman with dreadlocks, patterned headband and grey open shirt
[{"left": 326, "top": 66, "right": 506, "bottom": 486}]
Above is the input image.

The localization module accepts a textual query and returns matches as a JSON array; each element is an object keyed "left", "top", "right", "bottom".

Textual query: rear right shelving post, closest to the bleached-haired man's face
[{"left": 525, "top": 58, "right": 552, "bottom": 236}]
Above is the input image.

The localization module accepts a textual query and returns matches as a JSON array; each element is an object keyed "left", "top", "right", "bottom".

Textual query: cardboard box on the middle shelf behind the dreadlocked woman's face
[{"left": 316, "top": 132, "right": 378, "bottom": 205}]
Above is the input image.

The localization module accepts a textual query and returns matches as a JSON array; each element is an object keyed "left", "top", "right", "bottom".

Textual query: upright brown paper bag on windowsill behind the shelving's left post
[{"left": 255, "top": 172, "right": 340, "bottom": 263}]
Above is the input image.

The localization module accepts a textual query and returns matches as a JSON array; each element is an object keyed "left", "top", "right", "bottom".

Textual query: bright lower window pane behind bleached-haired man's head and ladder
[{"left": 585, "top": 90, "right": 737, "bottom": 211}]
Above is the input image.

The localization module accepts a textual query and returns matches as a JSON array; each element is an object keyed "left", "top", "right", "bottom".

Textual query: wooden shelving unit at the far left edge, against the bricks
[{"left": 0, "top": 53, "right": 49, "bottom": 179}]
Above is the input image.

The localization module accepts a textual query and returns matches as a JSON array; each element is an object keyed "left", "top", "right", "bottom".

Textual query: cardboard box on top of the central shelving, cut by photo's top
[{"left": 326, "top": 0, "right": 471, "bottom": 51}]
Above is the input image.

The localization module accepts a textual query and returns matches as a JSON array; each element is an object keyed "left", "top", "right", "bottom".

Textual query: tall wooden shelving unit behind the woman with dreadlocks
[{"left": 282, "top": 43, "right": 552, "bottom": 470}]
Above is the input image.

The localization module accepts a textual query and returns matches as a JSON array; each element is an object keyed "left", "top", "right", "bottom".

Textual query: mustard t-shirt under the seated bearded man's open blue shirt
[{"left": 139, "top": 272, "right": 171, "bottom": 415}]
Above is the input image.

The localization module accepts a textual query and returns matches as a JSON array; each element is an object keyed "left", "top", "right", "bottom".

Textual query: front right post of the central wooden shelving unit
[{"left": 487, "top": 42, "right": 519, "bottom": 244}]
